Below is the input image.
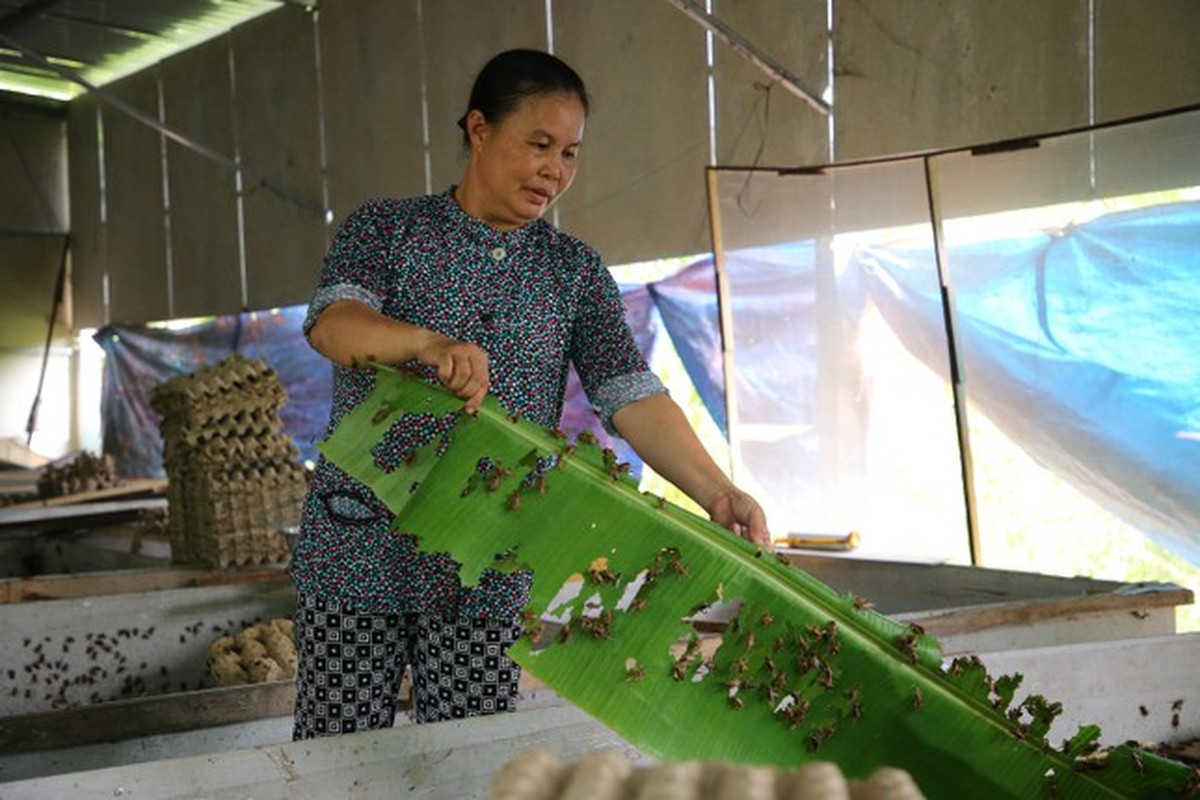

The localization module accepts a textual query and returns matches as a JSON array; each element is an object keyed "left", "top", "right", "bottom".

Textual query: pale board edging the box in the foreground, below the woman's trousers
[{"left": 0, "top": 705, "right": 644, "bottom": 800}]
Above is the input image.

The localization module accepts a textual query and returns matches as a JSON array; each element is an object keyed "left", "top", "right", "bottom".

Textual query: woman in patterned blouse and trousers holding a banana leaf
[{"left": 292, "top": 50, "right": 768, "bottom": 739}]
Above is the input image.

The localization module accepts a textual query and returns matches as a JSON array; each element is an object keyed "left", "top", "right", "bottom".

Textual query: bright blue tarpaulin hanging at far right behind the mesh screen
[{"left": 853, "top": 203, "right": 1200, "bottom": 564}]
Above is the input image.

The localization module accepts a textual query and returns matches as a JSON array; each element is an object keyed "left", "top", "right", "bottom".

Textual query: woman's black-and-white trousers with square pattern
[{"left": 292, "top": 595, "right": 521, "bottom": 739}]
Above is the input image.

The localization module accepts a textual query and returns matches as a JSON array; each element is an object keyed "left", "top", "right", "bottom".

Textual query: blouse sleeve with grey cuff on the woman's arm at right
[{"left": 571, "top": 255, "right": 667, "bottom": 435}]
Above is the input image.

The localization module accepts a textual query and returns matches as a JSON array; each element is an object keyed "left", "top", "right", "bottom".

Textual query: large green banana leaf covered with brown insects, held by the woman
[{"left": 320, "top": 367, "right": 1196, "bottom": 800}]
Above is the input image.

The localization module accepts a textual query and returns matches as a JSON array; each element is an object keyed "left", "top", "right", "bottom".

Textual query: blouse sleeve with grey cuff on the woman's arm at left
[{"left": 302, "top": 199, "right": 395, "bottom": 336}]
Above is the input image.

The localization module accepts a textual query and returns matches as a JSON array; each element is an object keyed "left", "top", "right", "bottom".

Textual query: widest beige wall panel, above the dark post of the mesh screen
[{"left": 834, "top": 0, "right": 1088, "bottom": 161}]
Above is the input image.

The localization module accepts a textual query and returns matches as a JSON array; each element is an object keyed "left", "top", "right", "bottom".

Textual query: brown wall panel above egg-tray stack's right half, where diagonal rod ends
[{"left": 233, "top": 7, "right": 325, "bottom": 308}]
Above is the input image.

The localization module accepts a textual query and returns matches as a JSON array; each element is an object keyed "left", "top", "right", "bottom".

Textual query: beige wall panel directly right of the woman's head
[{"left": 554, "top": 0, "right": 712, "bottom": 264}]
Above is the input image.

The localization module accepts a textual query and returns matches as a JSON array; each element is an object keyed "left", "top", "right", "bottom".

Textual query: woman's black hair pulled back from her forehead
[{"left": 458, "top": 49, "right": 589, "bottom": 148}]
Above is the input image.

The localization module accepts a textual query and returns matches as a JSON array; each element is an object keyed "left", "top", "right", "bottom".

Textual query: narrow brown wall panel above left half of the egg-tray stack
[{"left": 162, "top": 36, "right": 242, "bottom": 317}]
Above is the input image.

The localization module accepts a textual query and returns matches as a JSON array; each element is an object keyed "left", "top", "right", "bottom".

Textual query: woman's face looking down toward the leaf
[{"left": 467, "top": 92, "right": 586, "bottom": 230}]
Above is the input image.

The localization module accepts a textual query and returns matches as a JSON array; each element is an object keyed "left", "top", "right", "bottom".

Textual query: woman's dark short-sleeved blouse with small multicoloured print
[{"left": 289, "top": 187, "right": 666, "bottom": 620}]
